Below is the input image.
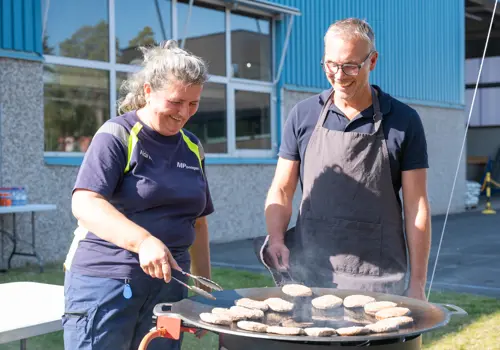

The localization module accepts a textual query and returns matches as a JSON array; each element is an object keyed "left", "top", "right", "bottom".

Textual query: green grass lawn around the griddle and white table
[{"left": 0, "top": 265, "right": 500, "bottom": 350}]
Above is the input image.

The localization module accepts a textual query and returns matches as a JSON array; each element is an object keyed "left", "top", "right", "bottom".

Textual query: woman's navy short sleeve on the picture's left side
[{"left": 73, "top": 125, "right": 127, "bottom": 199}]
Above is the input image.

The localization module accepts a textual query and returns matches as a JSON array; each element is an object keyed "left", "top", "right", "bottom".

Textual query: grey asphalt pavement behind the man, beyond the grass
[{"left": 211, "top": 199, "right": 500, "bottom": 298}]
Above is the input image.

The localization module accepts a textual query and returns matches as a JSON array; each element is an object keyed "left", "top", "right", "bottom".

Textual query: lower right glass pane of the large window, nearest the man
[{"left": 235, "top": 91, "right": 271, "bottom": 149}]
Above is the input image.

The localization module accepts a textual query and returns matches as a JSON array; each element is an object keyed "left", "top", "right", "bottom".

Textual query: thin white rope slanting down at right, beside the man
[{"left": 427, "top": 1, "right": 497, "bottom": 300}]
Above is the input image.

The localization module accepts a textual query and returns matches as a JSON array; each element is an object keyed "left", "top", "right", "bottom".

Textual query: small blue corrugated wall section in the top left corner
[{"left": 0, "top": 0, "right": 43, "bottom": 57}]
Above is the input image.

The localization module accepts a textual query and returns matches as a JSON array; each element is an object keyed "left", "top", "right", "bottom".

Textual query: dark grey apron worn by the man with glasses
[{"left": 259, "top": 88, "right": 407, "bottom": 295}]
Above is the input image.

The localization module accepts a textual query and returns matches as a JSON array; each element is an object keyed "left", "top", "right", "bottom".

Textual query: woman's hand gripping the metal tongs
[{"left": 139, "top": 236, "right": 181, "bottom": 283}]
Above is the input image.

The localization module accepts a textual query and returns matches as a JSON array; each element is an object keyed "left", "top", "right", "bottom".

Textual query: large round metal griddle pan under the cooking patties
[{"left": 139, "top": 287, "right": 467, "bottom": 350}]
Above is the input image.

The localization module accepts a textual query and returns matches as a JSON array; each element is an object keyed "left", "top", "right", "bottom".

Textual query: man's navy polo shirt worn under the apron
[{"left": 279, "top": 85, "right": 429, "bottom": 205}]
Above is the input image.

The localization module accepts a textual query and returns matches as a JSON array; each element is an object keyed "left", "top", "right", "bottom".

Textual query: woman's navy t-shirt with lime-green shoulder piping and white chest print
[{"left": 69, "top": 111, "right": 214, "bottom": 278}]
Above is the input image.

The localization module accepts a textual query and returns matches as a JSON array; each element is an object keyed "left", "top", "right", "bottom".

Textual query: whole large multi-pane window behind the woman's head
[{"left": 43, "top": 0, "right": 276, "bottom": 157}]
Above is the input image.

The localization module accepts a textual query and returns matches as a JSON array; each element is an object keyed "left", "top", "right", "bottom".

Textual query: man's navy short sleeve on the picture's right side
[{"left": 401, "top": 111, "right": 429, "bottom": 171}]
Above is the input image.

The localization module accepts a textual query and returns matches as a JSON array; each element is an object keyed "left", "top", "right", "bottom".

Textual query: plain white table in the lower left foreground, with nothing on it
[{"left": 0, "top": 282, "right": 64, "bottom": 350}]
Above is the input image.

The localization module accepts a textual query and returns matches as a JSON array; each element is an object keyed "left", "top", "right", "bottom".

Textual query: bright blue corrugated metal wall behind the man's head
[{"left": 274, "top": 0, "right": 465, "bottom": 106}]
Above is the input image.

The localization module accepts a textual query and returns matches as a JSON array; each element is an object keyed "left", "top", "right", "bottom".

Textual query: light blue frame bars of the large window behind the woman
[{"left": 44, "top": 0, "right": 278, "bottom": 159}]
